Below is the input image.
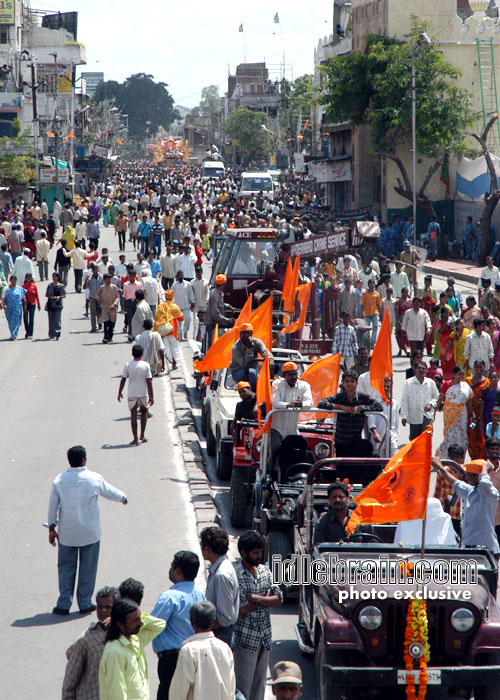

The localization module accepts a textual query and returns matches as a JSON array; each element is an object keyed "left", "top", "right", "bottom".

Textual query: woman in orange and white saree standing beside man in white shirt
[{"left": 437, "top": 365, "right": 473, "bottom": 459}]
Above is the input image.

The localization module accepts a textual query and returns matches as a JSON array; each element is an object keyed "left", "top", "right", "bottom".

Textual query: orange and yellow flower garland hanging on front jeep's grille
[{"left": 404, "top": 599, "right": 430, "bottom": 700}]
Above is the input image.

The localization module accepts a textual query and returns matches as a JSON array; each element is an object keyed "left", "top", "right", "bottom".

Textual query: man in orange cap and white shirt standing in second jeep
[{"left": 271, "top": 362, "right": 313, "bottom": 456}]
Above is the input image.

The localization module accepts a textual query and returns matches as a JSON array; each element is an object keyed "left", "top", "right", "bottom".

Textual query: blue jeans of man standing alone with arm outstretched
[{"left": 57, "top": 542, "right": 100, "bottom": 610}]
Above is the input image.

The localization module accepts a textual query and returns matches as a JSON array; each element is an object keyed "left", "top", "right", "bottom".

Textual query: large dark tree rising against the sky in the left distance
[{"left": 94, "top": 73, "right": 179, "bottom": 141}]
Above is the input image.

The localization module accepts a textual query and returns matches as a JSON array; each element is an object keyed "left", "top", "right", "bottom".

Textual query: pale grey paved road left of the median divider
[{"left": 0, "top": 229, "right": 203, "bottom": 700}]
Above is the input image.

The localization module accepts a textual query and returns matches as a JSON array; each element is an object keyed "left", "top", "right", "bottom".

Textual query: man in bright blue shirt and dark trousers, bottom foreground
[{"left": 151, "top": 550, "right": 205, "bottom": 700}]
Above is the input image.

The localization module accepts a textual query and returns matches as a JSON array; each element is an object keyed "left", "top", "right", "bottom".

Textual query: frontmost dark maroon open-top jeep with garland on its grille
[{"left": 295, "top": 460, "right": 500, "bottom": 700}]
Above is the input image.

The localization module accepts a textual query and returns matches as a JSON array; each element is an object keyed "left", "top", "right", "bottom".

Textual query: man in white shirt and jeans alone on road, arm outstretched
[{"left": 48, "top": 446, "right": 127, "bottom": 615}]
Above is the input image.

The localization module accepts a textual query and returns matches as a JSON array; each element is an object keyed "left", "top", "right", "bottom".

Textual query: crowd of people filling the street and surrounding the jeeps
[{"left": 6, "top": 163, "right": 500, "bottom": 700}]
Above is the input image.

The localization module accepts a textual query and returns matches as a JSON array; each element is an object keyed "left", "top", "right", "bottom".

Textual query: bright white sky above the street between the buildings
[{"left": 31, "top": 0, "right": 333, "bottom": 107}]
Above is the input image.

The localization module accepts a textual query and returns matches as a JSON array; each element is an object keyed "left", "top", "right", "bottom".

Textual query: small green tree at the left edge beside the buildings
[{"left": 0, "top": 119, "right": 36, "bottom": 187}]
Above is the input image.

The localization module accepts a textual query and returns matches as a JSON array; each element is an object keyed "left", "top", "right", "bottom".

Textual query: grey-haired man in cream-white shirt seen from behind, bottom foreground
[{"left": 168, "top": 600, "right": 236, "bottom": 700}]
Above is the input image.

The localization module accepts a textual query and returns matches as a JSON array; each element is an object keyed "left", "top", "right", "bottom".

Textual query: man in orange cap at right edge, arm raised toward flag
[{"left": 432, "top": 457, "right": 500, "bottom": 557}]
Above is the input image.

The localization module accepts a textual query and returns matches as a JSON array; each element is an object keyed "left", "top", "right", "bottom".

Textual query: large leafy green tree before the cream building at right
[{"left": 319, "top": 17, "right": 475, "bottom": 216}]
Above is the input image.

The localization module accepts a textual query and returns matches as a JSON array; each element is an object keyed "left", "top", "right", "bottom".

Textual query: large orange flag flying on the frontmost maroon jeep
[{"left": 347, "top": 427, "right": 432, "bottom": 534}]
